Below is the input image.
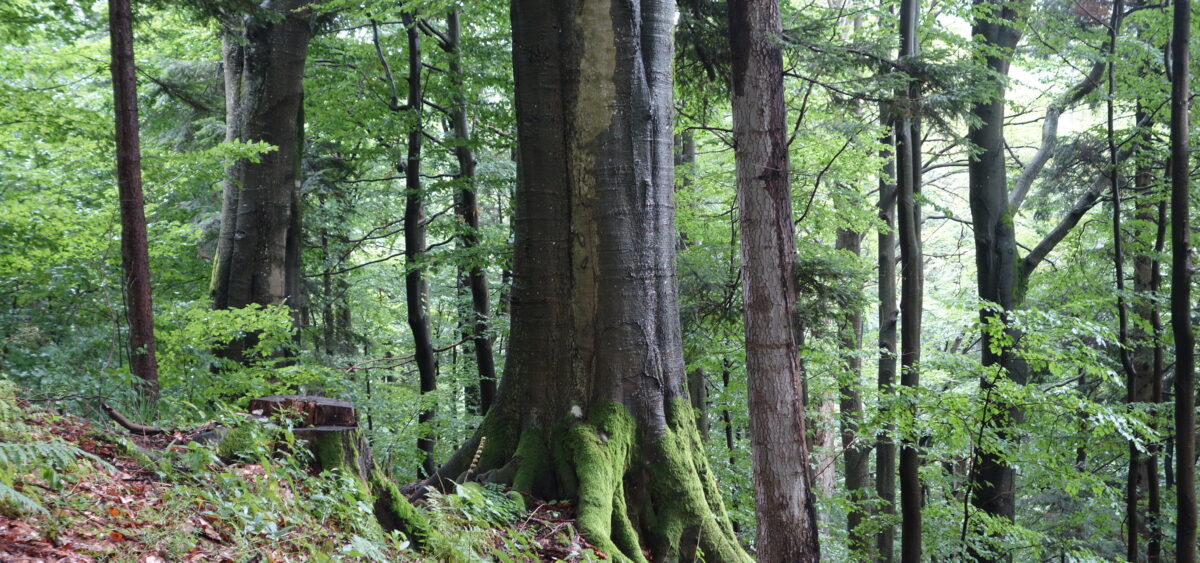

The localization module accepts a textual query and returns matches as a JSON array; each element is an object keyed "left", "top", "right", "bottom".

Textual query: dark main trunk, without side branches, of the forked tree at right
[{"left": 964, "top": 0, "right": 1027, "bottom": 540}]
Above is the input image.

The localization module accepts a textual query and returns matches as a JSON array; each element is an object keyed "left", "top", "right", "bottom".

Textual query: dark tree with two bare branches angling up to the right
[{"left": 962, "top": 5, "right": 1133, "bottom": 544}]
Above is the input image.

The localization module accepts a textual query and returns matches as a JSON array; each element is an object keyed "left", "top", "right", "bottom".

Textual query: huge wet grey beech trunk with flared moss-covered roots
[{"left": 417, "top": 0, "right": 749, "bottom": 561}]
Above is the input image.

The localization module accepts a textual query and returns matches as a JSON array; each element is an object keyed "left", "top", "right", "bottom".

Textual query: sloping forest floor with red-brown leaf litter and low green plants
[{"left": 0, "top": 397, "right": 605, "bottom": 563}]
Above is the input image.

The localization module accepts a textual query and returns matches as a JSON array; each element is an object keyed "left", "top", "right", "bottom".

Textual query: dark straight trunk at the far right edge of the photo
[{"left": 1170, "top": 0, "right": 1196, "bottom": 554}]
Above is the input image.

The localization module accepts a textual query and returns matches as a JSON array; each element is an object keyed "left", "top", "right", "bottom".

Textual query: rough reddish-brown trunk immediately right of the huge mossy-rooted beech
[{"left": 728, "top": 0, "right": 820, "bottom": 554}]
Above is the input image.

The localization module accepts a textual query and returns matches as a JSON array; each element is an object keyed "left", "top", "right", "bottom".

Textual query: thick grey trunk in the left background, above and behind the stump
[{"left": 211, "top": 0, "right": 312, "bottom": 361}]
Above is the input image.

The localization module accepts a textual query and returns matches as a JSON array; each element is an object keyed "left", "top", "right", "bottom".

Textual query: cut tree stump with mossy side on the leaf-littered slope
[{"left": 250, "top": 395, "right": 428, "bottom": 546}]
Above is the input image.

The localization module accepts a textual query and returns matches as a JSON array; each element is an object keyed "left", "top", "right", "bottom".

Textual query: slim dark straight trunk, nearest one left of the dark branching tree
[{"left": 895, "top": 0, "right": 924, "bottom": 556}]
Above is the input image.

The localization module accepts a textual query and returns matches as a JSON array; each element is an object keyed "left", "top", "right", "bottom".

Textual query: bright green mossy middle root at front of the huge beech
[{"left": 566, "top": 402, "right": 646, "bottom": 562}]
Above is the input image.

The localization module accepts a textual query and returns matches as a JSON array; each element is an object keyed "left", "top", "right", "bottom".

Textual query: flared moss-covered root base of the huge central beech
[{"left": 428, "top": 400, "right": 750, "bottom": 562}]
